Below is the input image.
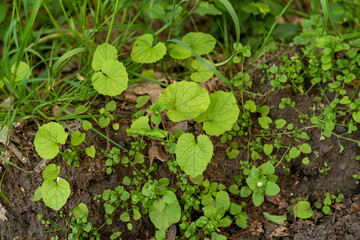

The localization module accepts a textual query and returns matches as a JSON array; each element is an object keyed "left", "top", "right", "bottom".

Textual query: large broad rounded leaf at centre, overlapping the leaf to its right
[{"left": 158, "top": 82, "right": 210, "bottom": 122}]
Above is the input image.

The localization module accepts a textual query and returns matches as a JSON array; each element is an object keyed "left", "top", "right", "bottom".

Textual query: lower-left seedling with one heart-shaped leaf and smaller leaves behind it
[{"left": 32, "top": 164, "right": 71, "bottom": 211}]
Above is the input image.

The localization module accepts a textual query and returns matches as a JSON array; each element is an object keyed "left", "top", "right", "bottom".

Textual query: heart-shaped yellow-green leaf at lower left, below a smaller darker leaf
[{"left": 41, "top": 178, "right": 71, "bottom": 211}]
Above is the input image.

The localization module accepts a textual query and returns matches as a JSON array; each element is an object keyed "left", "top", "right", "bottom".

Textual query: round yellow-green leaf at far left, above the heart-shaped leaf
[{"left": 34, "top": 122, "right": 68, "bottom": 159}]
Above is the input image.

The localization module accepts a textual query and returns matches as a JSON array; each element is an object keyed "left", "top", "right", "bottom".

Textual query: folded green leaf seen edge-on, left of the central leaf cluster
[{"left": 126, "top": 116, "right": 167, "bottom": 138}]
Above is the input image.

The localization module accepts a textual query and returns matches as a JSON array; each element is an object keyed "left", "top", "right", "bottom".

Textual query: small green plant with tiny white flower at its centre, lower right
[{"left": 240, "top": 162, "right": 280, "bottom": 206}]
